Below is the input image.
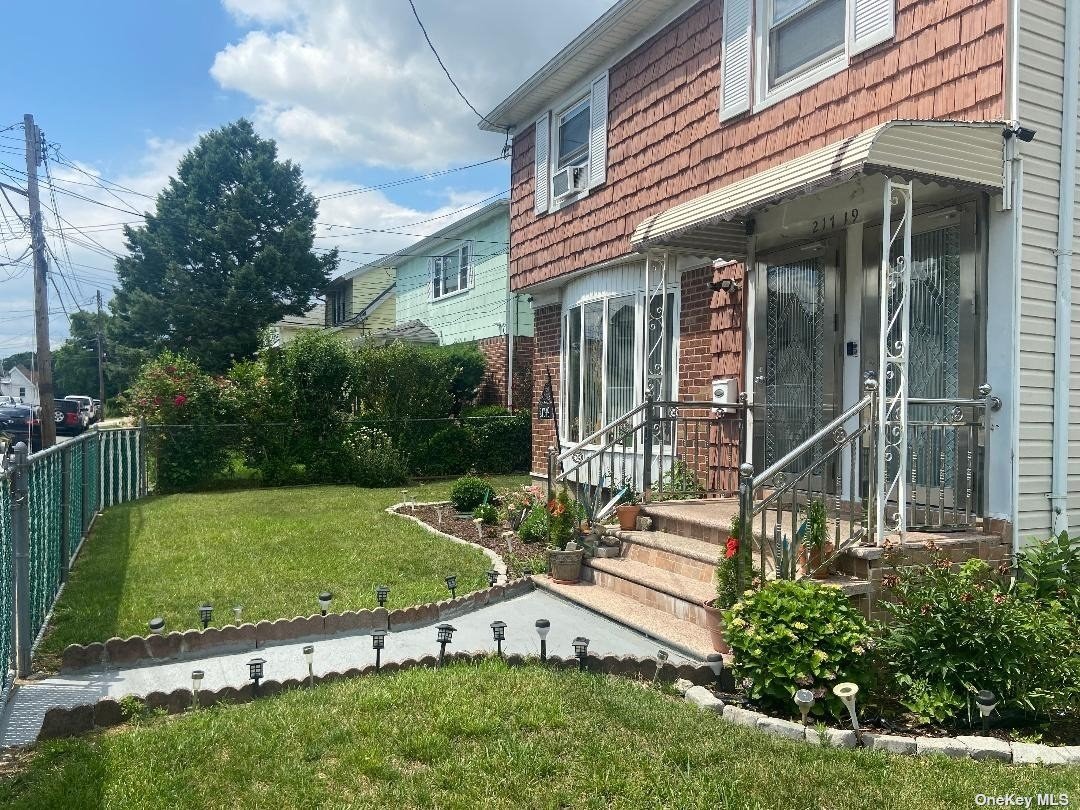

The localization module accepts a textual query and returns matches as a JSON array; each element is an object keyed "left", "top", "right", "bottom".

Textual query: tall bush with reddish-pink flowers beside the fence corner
[{"left": 127, "top": 352, "right": 229, "bottom": 491}]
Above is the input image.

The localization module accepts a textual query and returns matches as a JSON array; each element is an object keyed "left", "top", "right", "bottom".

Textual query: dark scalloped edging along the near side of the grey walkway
[{"left": 38, "top": 652, "right": 715, "bottom": 741}]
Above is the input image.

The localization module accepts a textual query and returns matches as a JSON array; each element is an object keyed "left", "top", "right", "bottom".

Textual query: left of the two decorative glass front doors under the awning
[{"left": 754, "top": 241, "right": 840, "bottom": 480}]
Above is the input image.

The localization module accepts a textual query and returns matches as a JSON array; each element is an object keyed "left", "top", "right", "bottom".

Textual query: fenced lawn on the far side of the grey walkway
[{"left": 39, "top": 476, "right": 524, "bottom": 666}]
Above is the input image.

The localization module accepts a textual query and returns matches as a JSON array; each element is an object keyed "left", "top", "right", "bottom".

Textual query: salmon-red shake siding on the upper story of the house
[{"left": 511, "top": 0, "right": 1005, "bottom": 289}]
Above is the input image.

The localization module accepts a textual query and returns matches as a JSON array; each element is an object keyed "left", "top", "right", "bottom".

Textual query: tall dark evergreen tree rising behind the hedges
[{"left": 109, "top": 119, "right": 337, "bottom": 373}]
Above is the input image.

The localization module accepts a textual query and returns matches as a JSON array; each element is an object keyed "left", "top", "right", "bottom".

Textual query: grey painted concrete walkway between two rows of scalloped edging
[{"left": 0, "top": 591, "right": 692, "bottom": 747}]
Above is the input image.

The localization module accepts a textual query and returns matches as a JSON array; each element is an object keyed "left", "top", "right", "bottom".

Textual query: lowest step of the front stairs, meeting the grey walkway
[{"left": 532, "top": 577, "right": 713, "bottom": 659}]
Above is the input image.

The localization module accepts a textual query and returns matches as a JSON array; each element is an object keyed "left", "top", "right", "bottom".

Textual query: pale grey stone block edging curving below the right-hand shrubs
[{"left": 675, "top": 680, "right": 1080, "bottom": 765}]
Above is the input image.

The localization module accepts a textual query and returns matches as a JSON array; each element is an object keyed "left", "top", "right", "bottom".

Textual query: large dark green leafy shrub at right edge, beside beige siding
[{"left": 881, "top": 554, "right": 1080, "bottom": 721}]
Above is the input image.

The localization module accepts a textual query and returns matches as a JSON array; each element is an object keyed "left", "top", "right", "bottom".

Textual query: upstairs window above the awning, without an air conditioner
[{"left": 767, "top": 0, "right": 847, "bottom": 90}]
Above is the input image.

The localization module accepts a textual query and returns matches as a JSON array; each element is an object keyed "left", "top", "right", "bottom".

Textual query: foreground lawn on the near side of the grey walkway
[{"left": 0, "top": 660, "right": 1080, "bottom": 810}]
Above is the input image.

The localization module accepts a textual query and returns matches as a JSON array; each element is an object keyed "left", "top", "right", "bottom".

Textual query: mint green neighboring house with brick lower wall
[{"left": 365, "top": 200, "right": 532, "bottom": 407}]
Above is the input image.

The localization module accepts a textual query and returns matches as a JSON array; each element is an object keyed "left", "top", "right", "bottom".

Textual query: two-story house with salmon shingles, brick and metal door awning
[{"left": 482, "top": 0, "right": 1080, "bottom": 639}]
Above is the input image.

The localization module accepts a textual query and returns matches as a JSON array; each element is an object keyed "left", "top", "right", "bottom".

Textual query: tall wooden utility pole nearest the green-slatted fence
[{"left": 23, "top": 112, "right": 56, "bottom": 449}]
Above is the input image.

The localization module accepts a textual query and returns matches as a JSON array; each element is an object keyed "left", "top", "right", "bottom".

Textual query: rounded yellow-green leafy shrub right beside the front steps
[{"left": 725, "top": 580, "right": 873, "bottom": 717}]
